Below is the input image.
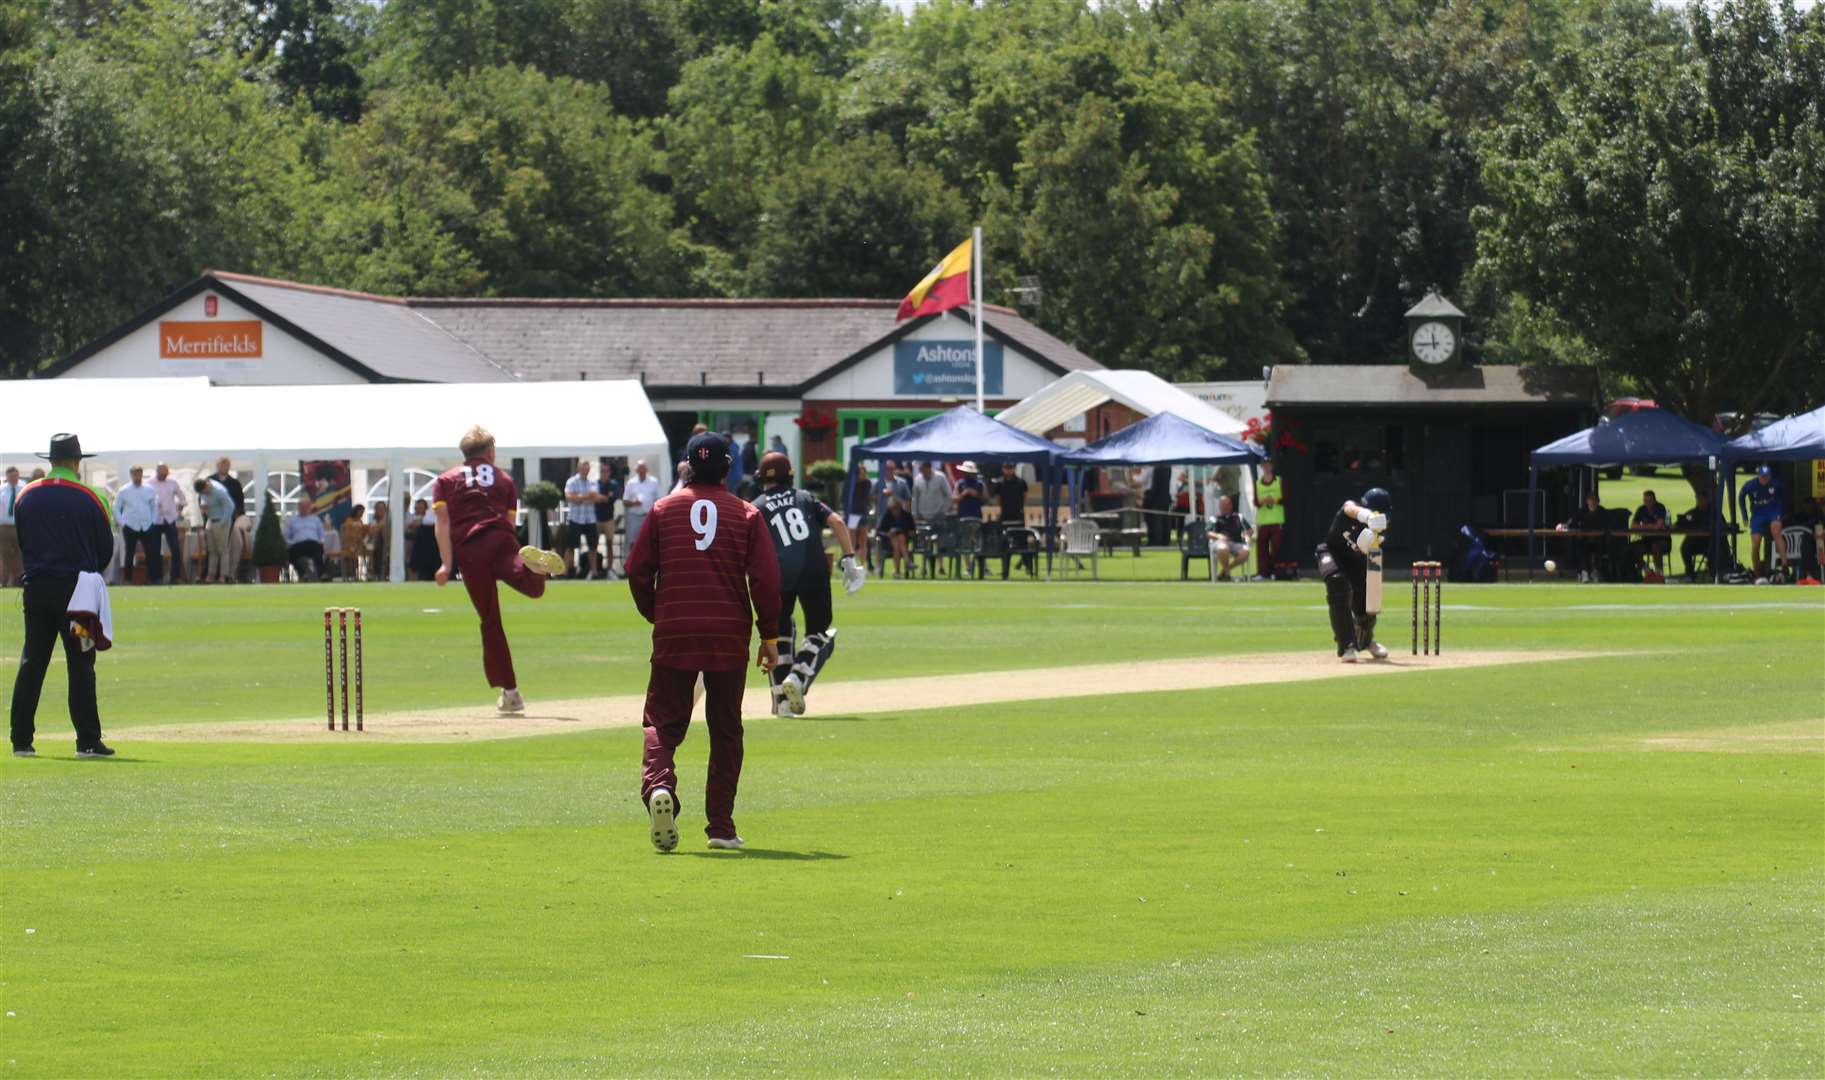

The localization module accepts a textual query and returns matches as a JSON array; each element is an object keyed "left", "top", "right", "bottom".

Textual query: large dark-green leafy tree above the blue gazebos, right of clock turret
[{"left": 1475, "top": 0, "right": 1825, "bottom": 430}]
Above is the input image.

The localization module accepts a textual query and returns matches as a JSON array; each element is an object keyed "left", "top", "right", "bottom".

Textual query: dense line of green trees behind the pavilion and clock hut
[{"left": 0, "top": 0, "right": 1825, "bottom": 416}]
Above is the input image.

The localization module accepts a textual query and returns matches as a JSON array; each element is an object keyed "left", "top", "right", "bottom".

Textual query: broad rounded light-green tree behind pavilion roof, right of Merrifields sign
[{"left": 318, "top": 68, "right": 684, "bottom": 296}]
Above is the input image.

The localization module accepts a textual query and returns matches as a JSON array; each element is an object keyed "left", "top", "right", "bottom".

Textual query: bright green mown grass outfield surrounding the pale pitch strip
[{"left": 0, "top": 582, "right": 1825, "bottom": 1076}]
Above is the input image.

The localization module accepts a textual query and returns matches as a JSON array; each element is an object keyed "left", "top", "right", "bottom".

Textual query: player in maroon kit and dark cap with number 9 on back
[{"left": 626, "top": 432, "right": 779, "bottom": 852}]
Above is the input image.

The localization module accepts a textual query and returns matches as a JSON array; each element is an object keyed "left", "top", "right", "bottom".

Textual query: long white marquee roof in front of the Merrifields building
[{"left": 0, "top": 378, "right": 672, "bottom": 582}]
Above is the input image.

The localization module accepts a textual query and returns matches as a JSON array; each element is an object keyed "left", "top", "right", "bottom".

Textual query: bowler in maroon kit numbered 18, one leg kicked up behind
[{"left": 431, "top": 427, "right": 564, "bottom": 713}]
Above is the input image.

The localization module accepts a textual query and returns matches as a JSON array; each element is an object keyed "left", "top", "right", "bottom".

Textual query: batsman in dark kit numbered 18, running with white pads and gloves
[{"left": 754, "top": 452, "right": 869, "bottom": 717}]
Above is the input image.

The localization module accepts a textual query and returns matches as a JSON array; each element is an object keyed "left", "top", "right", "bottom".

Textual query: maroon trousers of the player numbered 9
[{"left": 641, "top": 664, "right": 748, "bottom": 839}]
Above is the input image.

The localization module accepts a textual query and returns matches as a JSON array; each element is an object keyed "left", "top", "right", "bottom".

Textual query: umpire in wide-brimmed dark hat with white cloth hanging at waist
[{"left": 13, "top": 434, "right": 113, "bottom": 757}]
